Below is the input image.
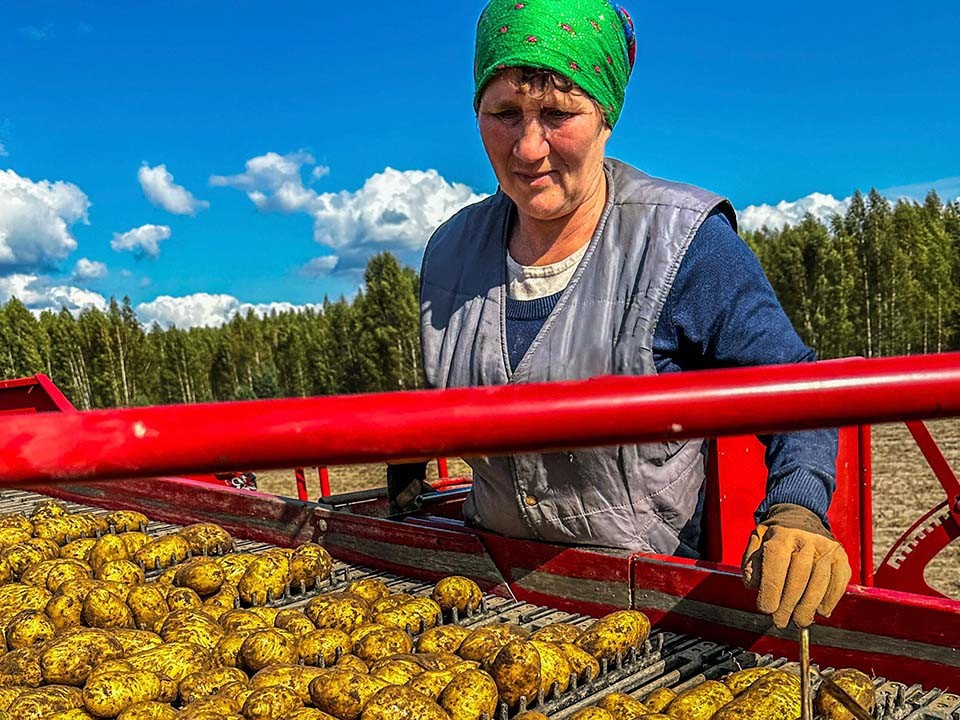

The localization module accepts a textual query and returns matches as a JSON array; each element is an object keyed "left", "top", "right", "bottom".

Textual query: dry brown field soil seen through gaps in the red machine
[{"left": 257, "top": 420, "right": 960, "bottom": 599}]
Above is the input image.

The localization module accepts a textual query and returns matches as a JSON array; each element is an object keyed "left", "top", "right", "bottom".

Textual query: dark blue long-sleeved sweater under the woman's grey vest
[{"left": 506, "top": 213, "right": 837, "bottom": 522}]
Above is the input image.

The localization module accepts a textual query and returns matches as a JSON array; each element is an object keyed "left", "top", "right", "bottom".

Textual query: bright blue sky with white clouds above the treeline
[{"left": 0, "top": 0, "right": 960, "bottom": 324}]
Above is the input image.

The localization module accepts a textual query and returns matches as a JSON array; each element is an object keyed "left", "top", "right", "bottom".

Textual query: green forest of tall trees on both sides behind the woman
[{"left": 0, "top": 190, "right": 960, "bottom": 409}]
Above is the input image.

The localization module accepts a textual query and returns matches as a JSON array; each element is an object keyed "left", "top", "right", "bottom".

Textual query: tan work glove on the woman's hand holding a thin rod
[{"left": 743, "top": 503, "right": 851, "bottom": 629}]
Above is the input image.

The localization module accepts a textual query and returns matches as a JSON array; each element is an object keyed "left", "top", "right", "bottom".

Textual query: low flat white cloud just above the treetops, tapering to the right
[{"left": 136, "top": 293, "right": 322, "bottom": 328}]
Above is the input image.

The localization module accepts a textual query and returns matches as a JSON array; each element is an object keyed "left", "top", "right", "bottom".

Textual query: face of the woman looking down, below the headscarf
[{"left": 478, "top": 76, "right": 610, "bottom": 220}]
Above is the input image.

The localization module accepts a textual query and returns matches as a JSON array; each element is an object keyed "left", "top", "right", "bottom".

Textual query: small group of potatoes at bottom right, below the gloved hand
[{"left": 514, "top": 667, "right": 876, "bottom": 720}]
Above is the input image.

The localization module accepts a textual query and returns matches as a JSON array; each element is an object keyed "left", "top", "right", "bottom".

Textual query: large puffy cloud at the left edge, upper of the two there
[{"left": 0, "top": 170, "right": 90, "bottom": 271}]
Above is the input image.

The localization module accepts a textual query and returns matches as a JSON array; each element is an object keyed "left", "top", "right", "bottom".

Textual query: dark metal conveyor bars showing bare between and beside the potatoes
[{"left": 0, "top": 489, "right": 960, "bottom": 720}]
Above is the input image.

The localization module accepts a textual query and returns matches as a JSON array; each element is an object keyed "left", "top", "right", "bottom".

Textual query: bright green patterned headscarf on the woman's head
[{"left": 474, "top": 0, "right": 635, "bottom": 127}]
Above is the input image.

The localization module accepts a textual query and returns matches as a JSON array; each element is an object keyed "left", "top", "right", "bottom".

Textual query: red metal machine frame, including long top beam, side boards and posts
[{"left": 0, "top": 354, "right": 960, "bottom": 691}]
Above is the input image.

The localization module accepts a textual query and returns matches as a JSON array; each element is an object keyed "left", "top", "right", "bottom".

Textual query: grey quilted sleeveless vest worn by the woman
[{"left": 420, "top": 159, "right": 735, "bottom": 554}]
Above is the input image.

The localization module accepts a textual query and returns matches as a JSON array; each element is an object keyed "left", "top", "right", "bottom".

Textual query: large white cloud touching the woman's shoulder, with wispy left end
[{"left": 210, "top": 152, "right": 485, "bottom": 270}]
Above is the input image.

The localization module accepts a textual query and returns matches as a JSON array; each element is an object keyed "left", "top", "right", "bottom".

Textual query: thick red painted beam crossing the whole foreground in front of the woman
[{"left": 0, "top": 353, "right": 960, "bottom": 485}]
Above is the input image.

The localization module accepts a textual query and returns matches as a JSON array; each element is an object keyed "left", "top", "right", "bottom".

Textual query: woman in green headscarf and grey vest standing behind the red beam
[{"left": 421, "top": 0, "right": 850, "bottom": 627}]
